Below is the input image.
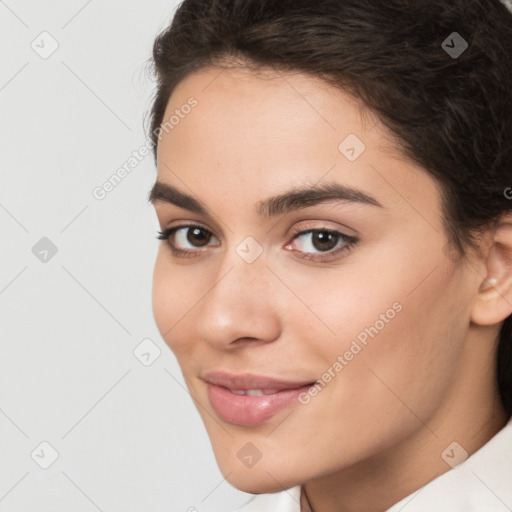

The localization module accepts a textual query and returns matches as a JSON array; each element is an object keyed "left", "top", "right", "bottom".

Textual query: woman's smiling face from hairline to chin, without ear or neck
[{"left": 152, "top": 68, "right": 474, "bottom": 493}]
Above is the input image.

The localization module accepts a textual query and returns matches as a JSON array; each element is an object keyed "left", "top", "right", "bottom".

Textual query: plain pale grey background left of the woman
[{"left": 0, "top": 0, "right": 251, "bottom": 512}]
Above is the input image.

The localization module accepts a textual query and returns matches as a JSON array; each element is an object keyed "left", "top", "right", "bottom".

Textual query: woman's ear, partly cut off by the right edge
[{"left": 471, "top": 212, "right": 512, "bottom": 325}]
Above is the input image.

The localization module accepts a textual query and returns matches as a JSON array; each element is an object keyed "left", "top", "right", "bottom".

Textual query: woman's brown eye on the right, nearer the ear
[{"left": 285, "top": 228, "right": 358, "bottom": 261}]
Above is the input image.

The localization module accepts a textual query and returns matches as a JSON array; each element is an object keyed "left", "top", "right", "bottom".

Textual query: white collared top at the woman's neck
[{"left": 235, "top": 418, "right": 512, "bottom": 512}]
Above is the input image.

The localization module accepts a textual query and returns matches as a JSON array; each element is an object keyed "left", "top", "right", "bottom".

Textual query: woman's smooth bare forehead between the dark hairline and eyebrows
[{"left": 158, "top": 67, "right": 438, "bottom": 223}]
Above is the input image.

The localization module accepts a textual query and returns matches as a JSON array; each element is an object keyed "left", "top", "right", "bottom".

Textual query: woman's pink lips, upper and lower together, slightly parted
[{"left": 202, "top": 371, "right": 315, "bottom": 426}]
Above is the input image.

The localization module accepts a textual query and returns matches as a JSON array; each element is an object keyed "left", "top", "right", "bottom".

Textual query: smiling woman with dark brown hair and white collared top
[{"left": 144, "top": 0, "right": 512, "bottom": 512}]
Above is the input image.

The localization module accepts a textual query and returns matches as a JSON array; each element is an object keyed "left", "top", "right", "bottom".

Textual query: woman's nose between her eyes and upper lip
[{"left": 196, "top": 251, "right": 281, "bottom": 350}]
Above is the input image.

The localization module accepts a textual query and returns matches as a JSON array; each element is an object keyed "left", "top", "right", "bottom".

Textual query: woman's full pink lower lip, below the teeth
[{"left": 207, "top": 383, "right": 312, "bottom": 427}]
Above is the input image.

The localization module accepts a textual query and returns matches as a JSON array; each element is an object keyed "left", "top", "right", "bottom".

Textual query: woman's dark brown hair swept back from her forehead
[{"left": 144, "top": 0, "right": 512, "bottom": 415}]
